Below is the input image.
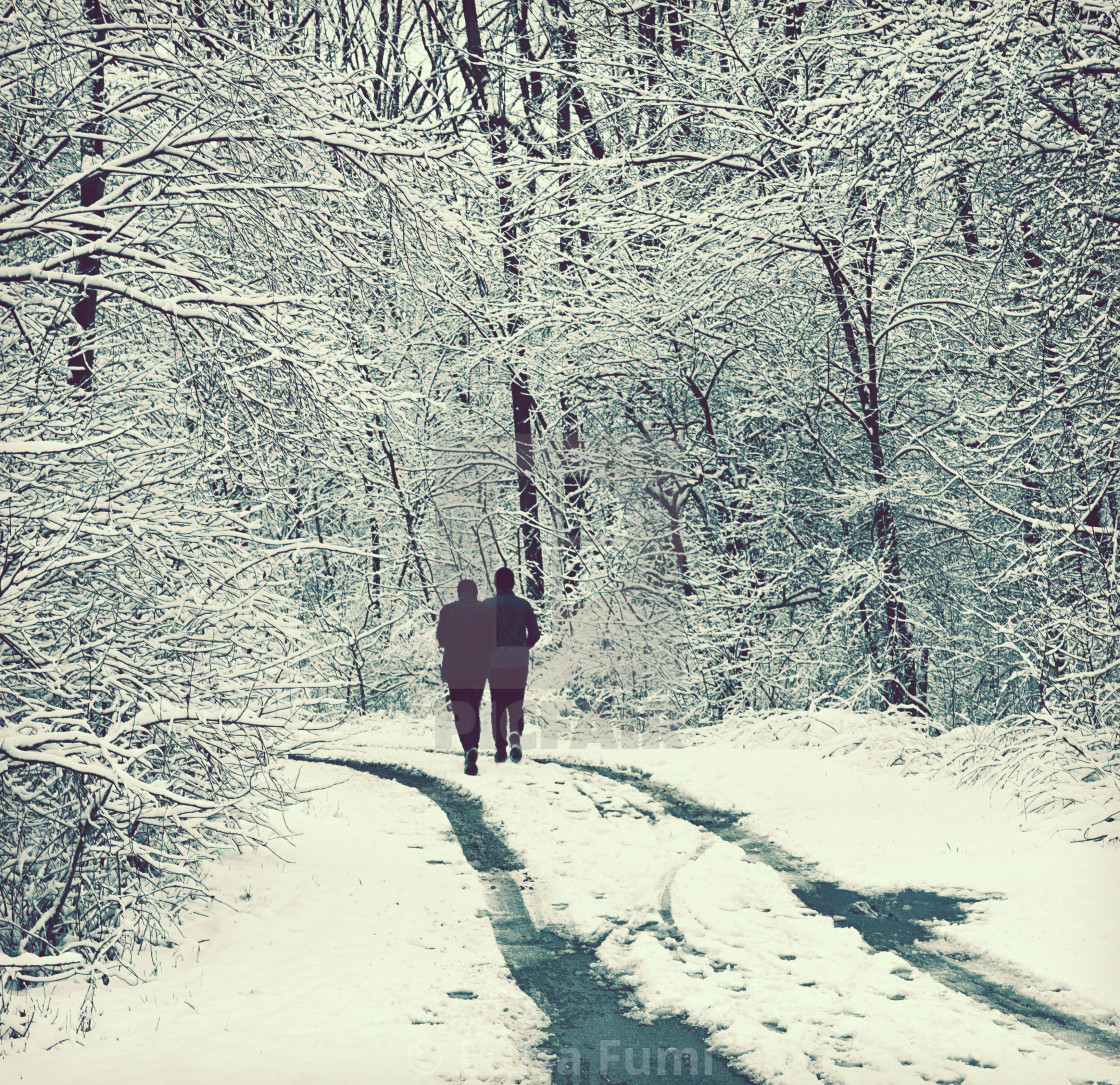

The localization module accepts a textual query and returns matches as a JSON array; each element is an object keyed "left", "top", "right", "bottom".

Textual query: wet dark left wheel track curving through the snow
[{"left": 291, "top": 754, "right": 757, "bottom": 1085}]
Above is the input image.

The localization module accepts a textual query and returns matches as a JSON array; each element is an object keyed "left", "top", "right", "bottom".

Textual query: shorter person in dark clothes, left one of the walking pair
[{"left": 436, "top": 580, "right": 495, "bottom": 776}]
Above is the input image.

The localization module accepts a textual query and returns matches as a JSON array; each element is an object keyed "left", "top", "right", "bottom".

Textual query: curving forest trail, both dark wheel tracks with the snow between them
[{"left": 291, "top": 750, "right": 1120, "bottom": 1083}]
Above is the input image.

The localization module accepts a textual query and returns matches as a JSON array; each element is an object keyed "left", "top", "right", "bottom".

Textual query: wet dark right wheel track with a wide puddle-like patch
[{"left": 541, "top": 757, "right": 1120, "bottom": 1059}]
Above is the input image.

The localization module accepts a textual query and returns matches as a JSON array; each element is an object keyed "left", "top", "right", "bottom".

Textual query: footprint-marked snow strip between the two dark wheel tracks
[{"left": 331, "top": 750, "right": 1120, "bottom": 1085}]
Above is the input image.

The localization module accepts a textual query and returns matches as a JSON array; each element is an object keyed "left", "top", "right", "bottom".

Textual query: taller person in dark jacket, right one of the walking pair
[{"left": 485, "top": 569, "right": 541, "bottom": 763}]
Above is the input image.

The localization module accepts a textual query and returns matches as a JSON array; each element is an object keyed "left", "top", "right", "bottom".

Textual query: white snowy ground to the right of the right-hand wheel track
[{"left": 560, "top": 735, "right": 1120, "bottom": 1020}]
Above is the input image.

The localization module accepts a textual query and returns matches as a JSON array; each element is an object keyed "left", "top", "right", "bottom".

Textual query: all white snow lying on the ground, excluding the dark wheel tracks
[{"left": 0, "top": 715, "right": 1120, "bottom": 1085}]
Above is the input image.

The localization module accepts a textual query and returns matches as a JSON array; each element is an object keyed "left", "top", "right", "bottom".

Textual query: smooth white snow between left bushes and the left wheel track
[{"left": 0, "top": 765, "right": 548, "bottom": 1085}]
